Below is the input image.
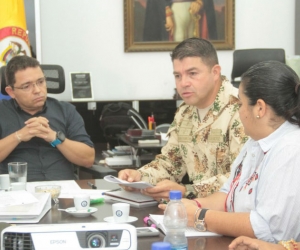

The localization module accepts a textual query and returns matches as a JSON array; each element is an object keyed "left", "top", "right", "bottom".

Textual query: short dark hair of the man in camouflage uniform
[{"left": 171, "top": 37, "right": 219, "bottom": 67}]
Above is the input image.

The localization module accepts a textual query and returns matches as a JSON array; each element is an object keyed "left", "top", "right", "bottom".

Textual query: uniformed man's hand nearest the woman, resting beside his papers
[{"left": 141, "top": 180, "right": 185, "bottom": 202}]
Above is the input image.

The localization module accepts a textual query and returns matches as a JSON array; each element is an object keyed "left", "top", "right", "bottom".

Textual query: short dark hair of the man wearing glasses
[{"left": 5, "top": 56, "right": 41, "bottom": 87}]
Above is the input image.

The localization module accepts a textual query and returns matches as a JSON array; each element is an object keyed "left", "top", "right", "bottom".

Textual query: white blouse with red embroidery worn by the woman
[{"left": 220, "top": 122, "right": 300, "bottom": 243}]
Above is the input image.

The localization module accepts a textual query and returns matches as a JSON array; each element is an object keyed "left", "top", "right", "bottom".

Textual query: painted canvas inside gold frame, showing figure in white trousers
[{"left": 135, "top": 0, "right": 225, "bottom": 42}]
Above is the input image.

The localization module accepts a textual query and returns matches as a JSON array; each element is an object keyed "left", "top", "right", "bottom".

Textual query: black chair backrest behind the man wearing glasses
[{"left": 0, "top": 64, "right": 65, "bottom": 95}]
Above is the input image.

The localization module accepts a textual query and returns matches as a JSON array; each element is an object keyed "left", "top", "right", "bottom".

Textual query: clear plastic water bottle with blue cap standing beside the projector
[{"left": 163, "top": 190, "right": 188, "bottom": 250}]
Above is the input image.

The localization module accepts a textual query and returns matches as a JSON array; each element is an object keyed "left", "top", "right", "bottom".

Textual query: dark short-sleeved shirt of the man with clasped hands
[{"left": 0, "top": 97, "right": 94, "bottom": 181}]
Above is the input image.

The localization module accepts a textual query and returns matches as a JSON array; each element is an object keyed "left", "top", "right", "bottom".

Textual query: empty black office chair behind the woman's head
[{"left": 231, "top": 49, "right": 285, "bottom": 88}]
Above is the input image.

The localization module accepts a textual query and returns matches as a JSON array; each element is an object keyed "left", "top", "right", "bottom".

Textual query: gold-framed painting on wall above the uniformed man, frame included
[{"left": 124, "top": 0, "right": 235, "bottom": 52}]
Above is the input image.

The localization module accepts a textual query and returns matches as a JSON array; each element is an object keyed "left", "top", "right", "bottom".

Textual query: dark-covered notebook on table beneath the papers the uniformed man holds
[{"left": 103, "top": 190, "right": 158, "bottom": 207}]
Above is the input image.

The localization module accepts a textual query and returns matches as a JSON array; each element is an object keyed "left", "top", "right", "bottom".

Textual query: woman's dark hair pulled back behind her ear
[{"left": 241, "top": 61, "right": 300, "bottom": 126}]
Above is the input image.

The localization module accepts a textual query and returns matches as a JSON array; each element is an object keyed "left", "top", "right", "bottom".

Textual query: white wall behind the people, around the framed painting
[{"left": 36, "top": 0, "right": 295, "bottom": 101}]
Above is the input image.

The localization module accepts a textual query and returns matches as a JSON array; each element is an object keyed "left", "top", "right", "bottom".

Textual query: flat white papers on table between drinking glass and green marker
[{"left": 26, "top": 180, "right": 107, "bottom": 199}]
